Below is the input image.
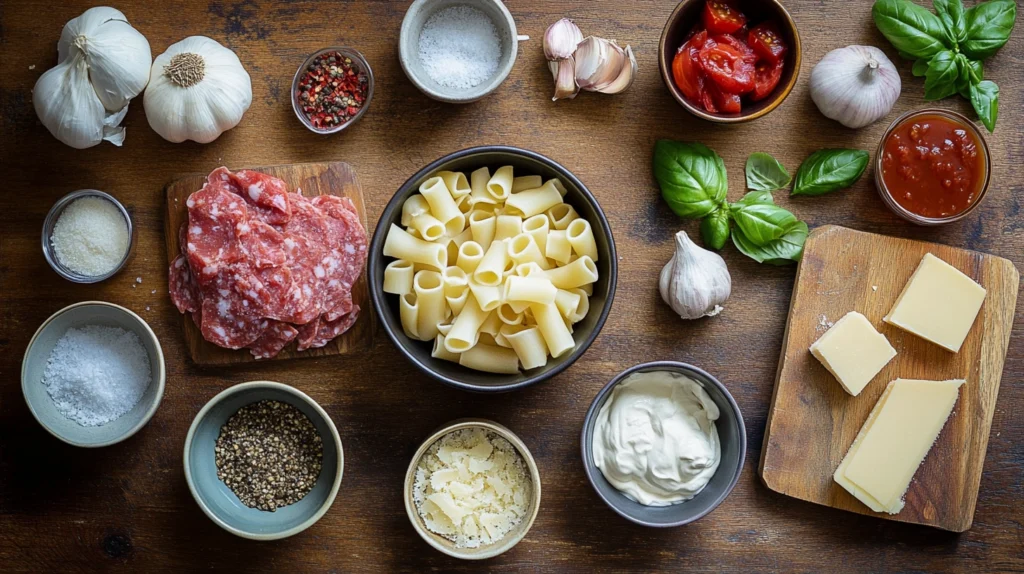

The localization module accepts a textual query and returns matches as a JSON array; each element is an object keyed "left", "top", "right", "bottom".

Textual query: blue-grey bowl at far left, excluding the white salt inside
[{"left": 22, "top": 301, "right": 166, "bottom": 447}]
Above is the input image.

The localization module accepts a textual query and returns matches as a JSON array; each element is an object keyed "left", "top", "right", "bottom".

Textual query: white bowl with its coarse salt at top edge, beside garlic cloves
[{"left": 398, "top": 0, "right": 519, "bottom": 103}]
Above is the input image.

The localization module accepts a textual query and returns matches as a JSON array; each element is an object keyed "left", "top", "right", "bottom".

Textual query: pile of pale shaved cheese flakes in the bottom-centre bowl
[{"left": 413, "top": 429, "right": 530, "bottom": 548}]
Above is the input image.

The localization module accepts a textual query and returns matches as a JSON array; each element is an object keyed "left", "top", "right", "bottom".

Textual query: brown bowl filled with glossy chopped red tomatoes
[{"left": 658, "top": 0, "right": 802, "bottom": 124}]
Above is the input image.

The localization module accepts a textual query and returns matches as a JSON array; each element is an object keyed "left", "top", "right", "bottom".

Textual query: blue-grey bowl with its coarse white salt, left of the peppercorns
[{"left": 22, "top": 301, "right": 166, "bottom": 447}]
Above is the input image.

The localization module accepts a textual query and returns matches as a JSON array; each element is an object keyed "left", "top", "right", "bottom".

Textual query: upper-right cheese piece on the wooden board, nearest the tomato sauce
[{"left": 883, "top": 253, "right": 985, "bottom": 353}]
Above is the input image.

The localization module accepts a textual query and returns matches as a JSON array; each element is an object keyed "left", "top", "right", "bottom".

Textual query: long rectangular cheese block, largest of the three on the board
[{"left": 833, "top": 379, "right": 964, "bottom": 515}]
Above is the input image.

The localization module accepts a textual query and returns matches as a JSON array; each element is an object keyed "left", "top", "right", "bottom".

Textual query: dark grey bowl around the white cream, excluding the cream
[{"left": 580, "top": 361, "right": 746, "bottom": 528}]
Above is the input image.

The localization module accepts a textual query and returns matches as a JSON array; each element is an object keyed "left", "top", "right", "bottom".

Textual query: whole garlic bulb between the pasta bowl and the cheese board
[{"left": 657, "top": 231, "right": 732, "bottom": 319}]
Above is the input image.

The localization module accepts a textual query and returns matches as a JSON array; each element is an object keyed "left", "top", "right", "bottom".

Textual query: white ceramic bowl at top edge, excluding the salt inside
[{"left": 398, "top": 0, "right": 519, "bottom": 103}]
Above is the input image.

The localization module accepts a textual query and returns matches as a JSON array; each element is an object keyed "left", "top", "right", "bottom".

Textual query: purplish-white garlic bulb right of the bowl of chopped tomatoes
[{"left": 811, "top": 46, "right": 900, "bottom": 128}]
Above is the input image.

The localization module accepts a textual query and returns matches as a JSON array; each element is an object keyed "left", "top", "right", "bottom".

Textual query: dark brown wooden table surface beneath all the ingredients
[{"left": 0, "top": 0, "right": 1024, "bottom": 572}]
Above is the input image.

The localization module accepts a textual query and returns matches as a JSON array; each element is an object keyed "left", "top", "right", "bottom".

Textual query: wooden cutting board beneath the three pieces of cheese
[{"left": 760, "top": 225, "right": 1020, "bottom": 532}]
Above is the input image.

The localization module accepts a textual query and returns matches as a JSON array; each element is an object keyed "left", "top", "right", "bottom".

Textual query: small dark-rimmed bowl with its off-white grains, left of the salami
[{"left": 42, "top": 189, "right": 135, "bottom": 283}]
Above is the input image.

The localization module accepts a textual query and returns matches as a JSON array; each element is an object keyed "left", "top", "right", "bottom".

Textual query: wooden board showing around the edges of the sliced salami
[{"left": 164, "top": 162, "right": 374, "bottom": 365}]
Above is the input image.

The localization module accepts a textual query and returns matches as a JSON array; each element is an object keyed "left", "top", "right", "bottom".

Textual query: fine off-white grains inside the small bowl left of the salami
[{"left": 50, "top": 197, "right": 128, "bottom": 277}]
